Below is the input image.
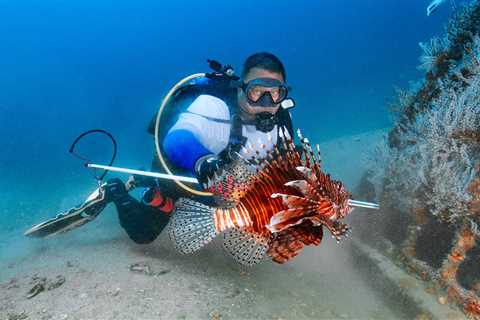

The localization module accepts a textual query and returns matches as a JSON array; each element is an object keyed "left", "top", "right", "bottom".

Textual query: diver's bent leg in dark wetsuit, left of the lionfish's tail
[{"left": 107, "top": 179, "right": 169, "bottom": 244}]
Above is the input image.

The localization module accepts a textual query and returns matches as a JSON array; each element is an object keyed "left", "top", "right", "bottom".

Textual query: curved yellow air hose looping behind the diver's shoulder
[{"left": 155, "top": 73, "right": 213, "bottom": 196}]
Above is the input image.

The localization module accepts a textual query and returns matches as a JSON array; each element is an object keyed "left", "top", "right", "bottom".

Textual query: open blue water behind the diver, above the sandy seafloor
[{"left": 0, "top": 0, "right": 451, "bottom": 228}]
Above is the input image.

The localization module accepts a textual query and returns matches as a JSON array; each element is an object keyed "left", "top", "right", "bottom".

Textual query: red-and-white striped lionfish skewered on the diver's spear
[{"left": 169, "top": 129, "right": 352, "bottom": 266}]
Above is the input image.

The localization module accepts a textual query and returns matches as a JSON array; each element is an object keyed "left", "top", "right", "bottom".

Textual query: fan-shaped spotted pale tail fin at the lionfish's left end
[{"left": 168, "top": 198, "right": 218, "bottom": 254}]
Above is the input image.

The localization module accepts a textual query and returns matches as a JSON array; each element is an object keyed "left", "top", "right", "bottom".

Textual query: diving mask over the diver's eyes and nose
[{"left": 242, "top": 78, "right": 288, "bottom": 107}]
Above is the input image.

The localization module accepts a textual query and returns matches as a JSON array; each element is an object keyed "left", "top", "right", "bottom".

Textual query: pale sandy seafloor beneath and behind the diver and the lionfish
[{"left": 0, "top": 130, "right": 399, "bottom": 319}]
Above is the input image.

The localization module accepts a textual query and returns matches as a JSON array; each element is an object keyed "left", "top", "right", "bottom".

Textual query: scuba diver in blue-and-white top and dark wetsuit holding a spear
[{"left": 25, "top": 52, "right": 294, "bottom": 244}]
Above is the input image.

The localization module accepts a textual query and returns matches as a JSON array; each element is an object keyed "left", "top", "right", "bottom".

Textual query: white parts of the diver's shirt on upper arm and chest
[{"left": 169, "top": 95, "right": 277, "bottom": 157}]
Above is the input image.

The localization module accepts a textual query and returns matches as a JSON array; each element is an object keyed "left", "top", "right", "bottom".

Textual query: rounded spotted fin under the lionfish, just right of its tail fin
[{"left": 223, "top": 229, "right": 268, "bottom": 267}]
